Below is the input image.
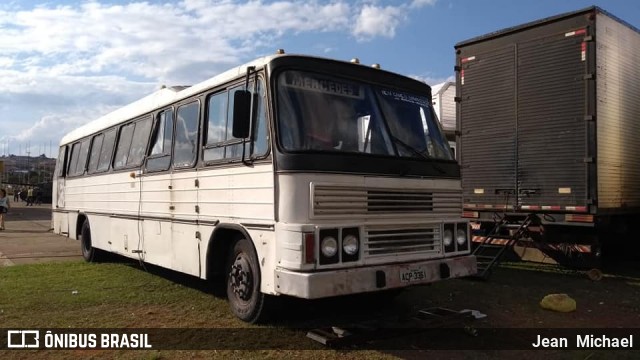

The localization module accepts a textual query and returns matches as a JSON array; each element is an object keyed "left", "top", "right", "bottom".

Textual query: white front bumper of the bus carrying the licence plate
[{"left": 275, "top": 255, "right": 477, "bottom": 299}]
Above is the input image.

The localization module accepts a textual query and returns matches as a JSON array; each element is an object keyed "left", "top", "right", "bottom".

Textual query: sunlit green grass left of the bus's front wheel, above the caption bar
[{"left": 0, "top": 262, "right": 230, "bottom": 327}]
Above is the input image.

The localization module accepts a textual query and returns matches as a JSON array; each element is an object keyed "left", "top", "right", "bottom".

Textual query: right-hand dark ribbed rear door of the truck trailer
[{"left": 516, "top": 32, "right": 587, "bottom": 209}]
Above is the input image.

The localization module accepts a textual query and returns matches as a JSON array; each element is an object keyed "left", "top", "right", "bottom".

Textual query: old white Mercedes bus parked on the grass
[{"left": 52, "top": 52, "right": 476, "bottom": 322}]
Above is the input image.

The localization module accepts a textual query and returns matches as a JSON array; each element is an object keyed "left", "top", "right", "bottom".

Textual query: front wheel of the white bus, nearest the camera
[{"left": 226, "top": 238, "right": 267, "bottom": 323}]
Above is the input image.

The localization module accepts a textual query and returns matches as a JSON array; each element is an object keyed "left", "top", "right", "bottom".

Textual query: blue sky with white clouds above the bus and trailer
[{"left": 0, "top": 0, "right": 640, "bottom": 157}]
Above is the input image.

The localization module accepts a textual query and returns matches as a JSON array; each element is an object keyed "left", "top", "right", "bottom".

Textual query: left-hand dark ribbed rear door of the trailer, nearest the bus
[{"left": 458, "top": 46, "right": 516, "bottom": 206}]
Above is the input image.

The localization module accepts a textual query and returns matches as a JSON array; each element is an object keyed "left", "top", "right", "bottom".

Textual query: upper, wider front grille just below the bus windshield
[{"left": 312, "top": 185, "right": 462, "bottom": 216}]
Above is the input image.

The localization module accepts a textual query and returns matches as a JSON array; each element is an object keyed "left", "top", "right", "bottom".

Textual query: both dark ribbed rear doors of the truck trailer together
[{"left": 458, "top": 30, "right": 588, "bottom": 210}]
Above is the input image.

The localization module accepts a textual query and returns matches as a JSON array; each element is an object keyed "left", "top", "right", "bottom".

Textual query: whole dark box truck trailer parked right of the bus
[{"left": 455, "top": 7, "right": 640, "bottom": 268}]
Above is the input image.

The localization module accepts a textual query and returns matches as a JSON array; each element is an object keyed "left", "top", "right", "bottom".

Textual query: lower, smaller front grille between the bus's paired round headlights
[{"left": 364, "top": 225, "right": 441, "bottom": 257}]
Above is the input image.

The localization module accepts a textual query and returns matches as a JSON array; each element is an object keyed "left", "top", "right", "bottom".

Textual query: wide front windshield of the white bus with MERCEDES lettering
[{"left": 277, "top": 70, "right": 453, "bottom": 160}]
